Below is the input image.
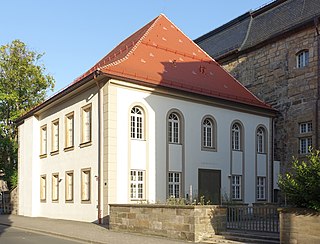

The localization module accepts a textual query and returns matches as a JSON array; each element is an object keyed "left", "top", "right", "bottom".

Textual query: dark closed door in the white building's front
[{"left": 198, "top": 169, "right": 221, "bottom": 204}]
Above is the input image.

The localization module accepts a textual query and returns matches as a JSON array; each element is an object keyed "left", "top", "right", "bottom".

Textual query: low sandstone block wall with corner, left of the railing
[{"left": 110, "top": 204, "right": 226, "bottom": 242}]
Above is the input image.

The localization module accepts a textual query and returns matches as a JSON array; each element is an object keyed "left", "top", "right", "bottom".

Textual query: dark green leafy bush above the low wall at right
[{"left": 279, "top": 149, "right": 320, "bottom": 211}]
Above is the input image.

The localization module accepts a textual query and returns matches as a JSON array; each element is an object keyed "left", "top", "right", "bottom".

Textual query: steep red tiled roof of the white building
[{"left": 74, "top": 14, "right": 271, "bottom": 109}]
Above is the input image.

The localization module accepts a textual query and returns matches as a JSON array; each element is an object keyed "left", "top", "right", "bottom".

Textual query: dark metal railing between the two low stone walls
[{"left": 227, "top": 206, "right": 279, "bottom": 233}]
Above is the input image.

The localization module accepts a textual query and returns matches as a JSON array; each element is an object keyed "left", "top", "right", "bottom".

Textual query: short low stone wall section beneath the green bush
[{"left": 279, "top": 208, "right": 320, "bottom": 244}]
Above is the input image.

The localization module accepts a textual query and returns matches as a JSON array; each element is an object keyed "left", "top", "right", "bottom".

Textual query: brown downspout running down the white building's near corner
[{"left": 93, "top": 70, "right": 103, "bottom": 224}]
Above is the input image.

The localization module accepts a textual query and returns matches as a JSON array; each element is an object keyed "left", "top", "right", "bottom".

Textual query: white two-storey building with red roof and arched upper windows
[{"left": 18, "top": 15, "right": 275, "bottom": 221}]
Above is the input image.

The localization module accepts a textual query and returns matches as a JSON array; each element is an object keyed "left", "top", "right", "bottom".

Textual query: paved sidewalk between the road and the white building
[{"left": 0, "top": 215, "right": 190, "bottom": 244}]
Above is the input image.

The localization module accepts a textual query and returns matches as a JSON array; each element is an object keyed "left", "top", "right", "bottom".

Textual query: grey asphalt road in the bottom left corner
[{"left": 0, "top": 225, "right": 84, "bottom": 244}]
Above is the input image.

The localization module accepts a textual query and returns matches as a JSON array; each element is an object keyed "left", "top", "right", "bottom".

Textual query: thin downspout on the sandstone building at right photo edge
[{"left": 314, "top": 17, "right": 320, "bottom": 149}]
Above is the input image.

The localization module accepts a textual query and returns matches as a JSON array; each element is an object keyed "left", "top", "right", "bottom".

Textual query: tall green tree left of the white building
[{"left": 0, "top": 40, "right": 54, "bottom": 189}]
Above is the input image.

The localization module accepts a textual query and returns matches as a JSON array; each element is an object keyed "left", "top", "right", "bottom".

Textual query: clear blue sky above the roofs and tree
[{"left": 0, "top": 0, "right": 270, "bottom": 95}]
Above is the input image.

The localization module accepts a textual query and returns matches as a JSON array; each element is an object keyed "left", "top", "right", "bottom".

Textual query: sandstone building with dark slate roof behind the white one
[{"left": 195, "top": 0, "right": 320, "bottom": 200}]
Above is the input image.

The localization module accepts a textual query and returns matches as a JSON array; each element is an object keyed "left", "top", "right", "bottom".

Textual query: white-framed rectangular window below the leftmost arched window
[{"left": 130, "top": 170, "right": 144, "bottom": 200}]
